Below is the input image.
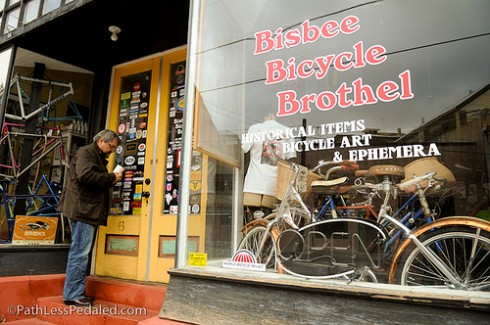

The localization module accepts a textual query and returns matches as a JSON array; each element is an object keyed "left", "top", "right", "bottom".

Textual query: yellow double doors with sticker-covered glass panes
[{"left": 94, "top": 49, "right": 199, "bottom": 282}]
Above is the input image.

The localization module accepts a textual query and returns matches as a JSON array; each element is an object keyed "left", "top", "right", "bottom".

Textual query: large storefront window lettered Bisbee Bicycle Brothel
[{"left": 185, "top": 0, "right": 490, "bottom": 291}]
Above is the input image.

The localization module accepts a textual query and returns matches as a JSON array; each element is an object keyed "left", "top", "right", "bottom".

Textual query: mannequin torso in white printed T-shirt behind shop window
[{"left": 242, "top": 114, "right": 296, "bottom": 213}]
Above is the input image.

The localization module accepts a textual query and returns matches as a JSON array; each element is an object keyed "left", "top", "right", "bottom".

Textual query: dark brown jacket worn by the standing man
[{"left": 58, "top": 142, "right": 116, "bottom": 226}]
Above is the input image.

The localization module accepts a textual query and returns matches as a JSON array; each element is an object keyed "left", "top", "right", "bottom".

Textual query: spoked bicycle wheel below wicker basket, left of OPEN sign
[{"left": 238, "top": 225, "right": 276, "bottom": 270}]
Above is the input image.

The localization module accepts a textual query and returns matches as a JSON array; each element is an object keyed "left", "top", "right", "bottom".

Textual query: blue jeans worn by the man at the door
[{"left": 63, "top": 220, "right": 97, "bottom": 301}]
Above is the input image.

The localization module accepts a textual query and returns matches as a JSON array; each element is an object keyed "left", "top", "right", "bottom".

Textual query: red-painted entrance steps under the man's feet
[{"left": 0, "top": 274, "right": 189, "bottom": 325}]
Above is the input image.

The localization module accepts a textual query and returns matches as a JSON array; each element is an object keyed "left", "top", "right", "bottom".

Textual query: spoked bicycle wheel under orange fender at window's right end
[{"left": 397, "top": 227, "right": 490, "bottom": 291}]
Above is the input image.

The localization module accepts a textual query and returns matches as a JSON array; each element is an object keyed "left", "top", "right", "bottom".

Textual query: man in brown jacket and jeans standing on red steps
[{"left": 59, "top": 130, "right": 122, "bottom": 306}]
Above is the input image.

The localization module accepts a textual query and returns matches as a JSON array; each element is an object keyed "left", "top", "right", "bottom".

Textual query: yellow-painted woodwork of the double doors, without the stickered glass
[{"left": 94, "top": 48, "right": 197, "bottom": 282}]
